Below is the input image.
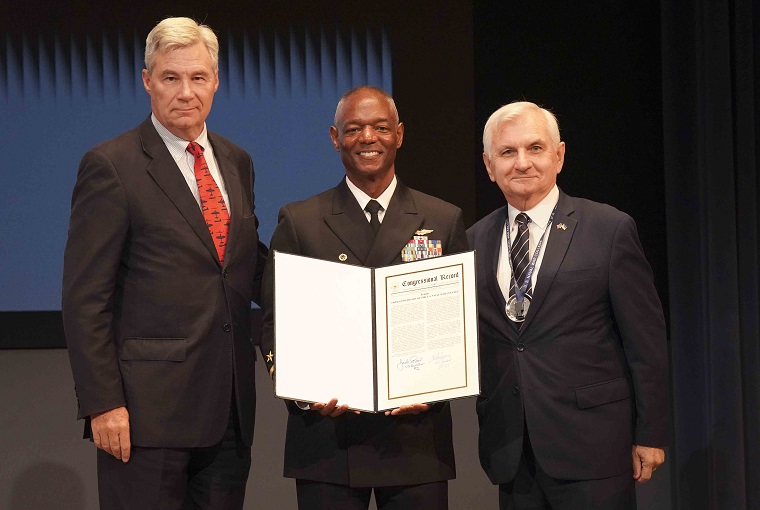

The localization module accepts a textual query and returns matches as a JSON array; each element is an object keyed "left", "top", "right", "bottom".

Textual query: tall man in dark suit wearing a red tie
[{"left": 63, "top": 18, "right": 266, "bottom": 510}]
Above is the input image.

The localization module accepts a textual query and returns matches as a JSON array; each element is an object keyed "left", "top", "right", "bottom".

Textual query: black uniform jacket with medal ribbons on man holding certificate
[{"left": 262, "top": 180, "right": 467, "bottom": 487}]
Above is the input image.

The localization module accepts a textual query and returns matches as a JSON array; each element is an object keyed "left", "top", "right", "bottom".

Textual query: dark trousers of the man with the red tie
[{"left": 98, "top": 406, "right": 251, "bottom": 510}]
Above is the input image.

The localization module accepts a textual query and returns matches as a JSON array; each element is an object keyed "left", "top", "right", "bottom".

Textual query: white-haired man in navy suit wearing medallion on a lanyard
[{"left": 467, "top": 102, "right": 669, "bottom": 509}]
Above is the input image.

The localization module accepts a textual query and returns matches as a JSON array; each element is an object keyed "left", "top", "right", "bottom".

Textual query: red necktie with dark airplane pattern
[{"left": 187, "top": 142, "right": 230, "bottom": 264}]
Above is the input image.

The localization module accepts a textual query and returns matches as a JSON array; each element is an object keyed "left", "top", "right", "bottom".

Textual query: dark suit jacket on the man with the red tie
[{"left": 63, "top": 118, "right": 266, "bottom": 447}]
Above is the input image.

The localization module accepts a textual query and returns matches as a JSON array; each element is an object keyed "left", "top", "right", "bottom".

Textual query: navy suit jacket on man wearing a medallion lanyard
[{"left": 467, "top": 192, "right": 669, "bottom": 484}]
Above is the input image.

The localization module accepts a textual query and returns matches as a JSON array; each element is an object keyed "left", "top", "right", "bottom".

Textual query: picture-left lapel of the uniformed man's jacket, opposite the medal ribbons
[{"left": 325, "top": 179, "right": 374, "bottom": 266}]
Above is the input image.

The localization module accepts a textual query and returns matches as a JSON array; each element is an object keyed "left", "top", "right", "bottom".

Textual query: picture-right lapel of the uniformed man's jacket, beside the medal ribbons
[{"left": 365, "top": 181, "right": 425, "bottom": 267}]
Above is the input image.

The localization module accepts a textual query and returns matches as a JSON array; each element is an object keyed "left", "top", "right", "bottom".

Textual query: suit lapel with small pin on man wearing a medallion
[{"left": 521, "top": 191, "right": 578, "bottom": 332}]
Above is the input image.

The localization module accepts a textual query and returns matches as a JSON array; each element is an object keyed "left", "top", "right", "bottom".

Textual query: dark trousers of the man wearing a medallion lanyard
[{"left": 499, "top": 429, "right": 636, "bottom": 510}]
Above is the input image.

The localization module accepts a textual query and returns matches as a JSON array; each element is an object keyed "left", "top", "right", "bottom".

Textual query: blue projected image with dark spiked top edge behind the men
[{"left": 0, "top": 26, "right": 392, "bottom": 311}]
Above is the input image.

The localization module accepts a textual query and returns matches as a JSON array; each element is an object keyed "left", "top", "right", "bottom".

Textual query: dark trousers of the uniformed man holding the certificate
[{"left": 296, "top": 480, "right": 449, "bottom": 510}]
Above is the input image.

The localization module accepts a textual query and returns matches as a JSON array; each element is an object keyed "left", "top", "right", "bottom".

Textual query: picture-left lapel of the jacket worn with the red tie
[{"left": 138, "top": 117, "right": 219, "bottom": 264}]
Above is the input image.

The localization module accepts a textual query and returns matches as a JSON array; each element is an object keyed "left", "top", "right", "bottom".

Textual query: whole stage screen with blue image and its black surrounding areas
[{"left": 0, "top": 0, "right": 475, "bottom": 348}]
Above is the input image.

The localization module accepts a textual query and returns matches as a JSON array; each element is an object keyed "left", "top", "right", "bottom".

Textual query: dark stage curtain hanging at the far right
[{"left": 661, "top": 0, "right": 760, "bottom": 510}]
